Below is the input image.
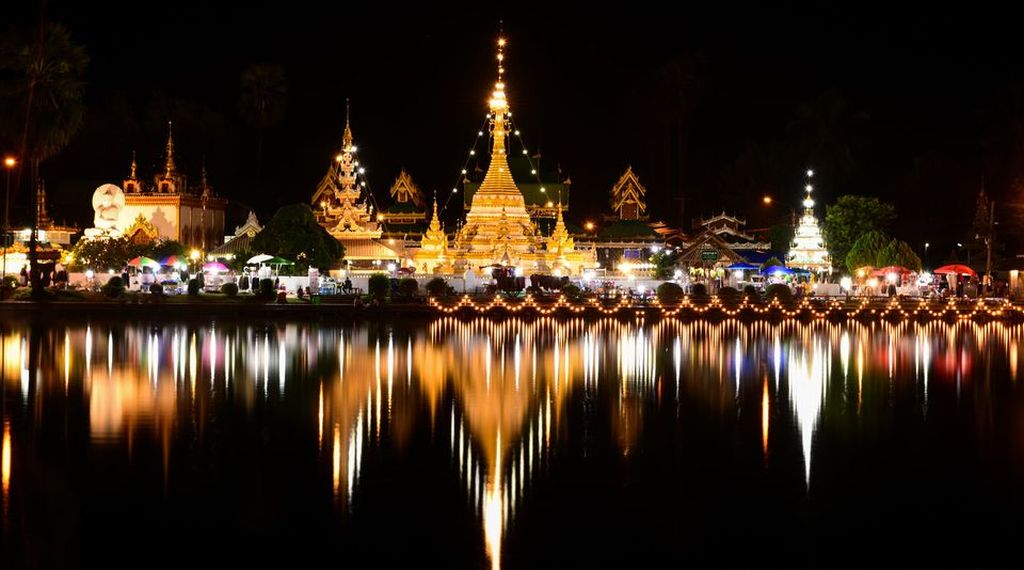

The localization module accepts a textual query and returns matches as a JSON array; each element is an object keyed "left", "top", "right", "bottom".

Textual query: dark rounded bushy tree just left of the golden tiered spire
[{"left": 252, "top": 204, "right": 345, "bottom": 273}]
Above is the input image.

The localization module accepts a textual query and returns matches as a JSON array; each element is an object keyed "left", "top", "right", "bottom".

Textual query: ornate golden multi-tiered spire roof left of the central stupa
[{"left": 311, "top": 102, "right": 381, "bottom": 242}]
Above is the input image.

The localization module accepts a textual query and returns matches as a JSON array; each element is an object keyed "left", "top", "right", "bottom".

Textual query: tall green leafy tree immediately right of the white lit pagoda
[{"left": 822, "top": 194, "right": 896, "bottom": 268}]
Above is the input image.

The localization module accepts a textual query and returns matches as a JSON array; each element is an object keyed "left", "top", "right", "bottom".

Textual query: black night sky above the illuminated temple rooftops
[{"left": 0, "top": 1, "right": 1024, "bottom": 259}]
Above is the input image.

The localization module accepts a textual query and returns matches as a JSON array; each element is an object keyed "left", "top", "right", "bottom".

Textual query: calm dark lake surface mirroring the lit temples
[{"left": 0, "top": 319, "right": 1024, "bottom": 568}]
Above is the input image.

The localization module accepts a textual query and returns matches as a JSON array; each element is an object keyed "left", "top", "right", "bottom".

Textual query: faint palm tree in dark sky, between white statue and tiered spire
[{"left": 239, "top": 63, "right": 288, "bottom": 182}]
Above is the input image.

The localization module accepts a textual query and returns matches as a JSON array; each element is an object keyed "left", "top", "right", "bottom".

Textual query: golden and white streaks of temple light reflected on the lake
[{"left": 2, "top": 318, "right": 1022, "bottom": 568}]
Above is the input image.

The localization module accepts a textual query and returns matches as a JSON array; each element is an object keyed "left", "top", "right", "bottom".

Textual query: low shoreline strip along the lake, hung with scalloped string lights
[{"left": 0, "top": 297, "right": 1024, "bottom": 322}]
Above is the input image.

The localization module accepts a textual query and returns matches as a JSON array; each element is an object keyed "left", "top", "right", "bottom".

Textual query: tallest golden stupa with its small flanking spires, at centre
[{"left": 415, "top": 38, "right": 595, "bottom": 274}]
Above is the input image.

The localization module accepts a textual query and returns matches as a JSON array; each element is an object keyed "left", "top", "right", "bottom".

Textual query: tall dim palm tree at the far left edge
[{"left": 0, "top": 18, "right": 89, "bottom": 296}]
